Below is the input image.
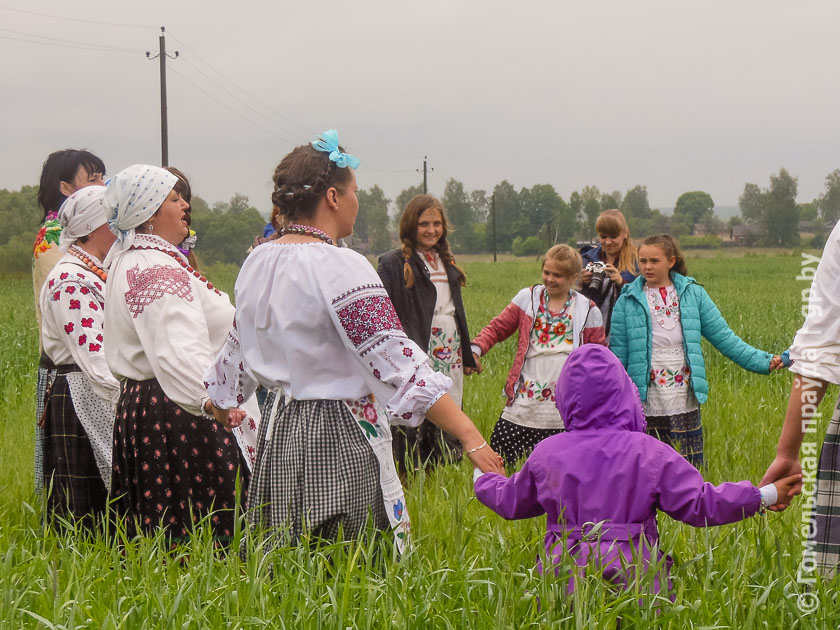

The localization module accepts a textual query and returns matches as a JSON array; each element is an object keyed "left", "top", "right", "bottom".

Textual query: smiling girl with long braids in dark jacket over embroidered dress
[{"left": 377, "top": 195, "right": 476, "bottom": 469}]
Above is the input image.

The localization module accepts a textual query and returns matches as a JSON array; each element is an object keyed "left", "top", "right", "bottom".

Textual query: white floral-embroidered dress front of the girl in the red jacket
[{"left": 501, "top": 291, "right": 585, "bottom": 430}]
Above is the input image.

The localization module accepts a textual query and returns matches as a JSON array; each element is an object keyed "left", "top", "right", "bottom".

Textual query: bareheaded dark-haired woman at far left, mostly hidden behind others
[{"left": 32, "top": 149, "right": 105, "bottom": 493}]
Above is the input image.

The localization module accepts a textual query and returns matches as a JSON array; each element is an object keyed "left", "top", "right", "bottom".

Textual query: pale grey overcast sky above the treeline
[{"left": 0, "top": 0, "right": 840, "bottom": 213}]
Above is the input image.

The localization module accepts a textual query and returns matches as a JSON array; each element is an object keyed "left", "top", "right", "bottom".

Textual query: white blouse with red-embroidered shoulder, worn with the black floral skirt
[{"left": 105, "top": 234, "right": 234, "bottom": 415}]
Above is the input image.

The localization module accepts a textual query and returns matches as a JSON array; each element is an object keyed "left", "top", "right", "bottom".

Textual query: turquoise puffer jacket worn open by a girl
[{"left": 610, "top": 271, "right": 773, "bottom": 405}]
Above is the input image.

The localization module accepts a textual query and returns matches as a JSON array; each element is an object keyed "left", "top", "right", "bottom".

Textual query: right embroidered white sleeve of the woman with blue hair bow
[{"left": 321, "top": 252, "right": 452, "bottom": 426}]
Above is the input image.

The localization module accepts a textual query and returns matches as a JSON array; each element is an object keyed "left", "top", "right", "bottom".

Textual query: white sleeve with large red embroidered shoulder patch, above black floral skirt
[{"left": 125, "top": 264, "right": 213, "bottom": 416}]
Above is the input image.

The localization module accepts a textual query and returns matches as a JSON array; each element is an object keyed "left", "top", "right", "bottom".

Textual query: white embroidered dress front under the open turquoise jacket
[{"left": 644, "top": 284, "right": 700, "bottom": 416}]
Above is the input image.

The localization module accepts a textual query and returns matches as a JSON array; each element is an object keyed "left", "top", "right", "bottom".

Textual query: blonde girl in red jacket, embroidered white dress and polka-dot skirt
[{"left": 472, "top": 245, "right": 605, "bottom": 463}]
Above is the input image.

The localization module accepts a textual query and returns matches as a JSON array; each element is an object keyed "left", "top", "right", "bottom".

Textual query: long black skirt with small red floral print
[{"left": 111, "top": 379, "right": 249, "bottom": 539}]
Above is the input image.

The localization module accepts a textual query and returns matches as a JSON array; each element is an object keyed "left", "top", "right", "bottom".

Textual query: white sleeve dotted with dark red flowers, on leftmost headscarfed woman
[{"left": 42, "top": 279, "right": 120, "bottom": 403}]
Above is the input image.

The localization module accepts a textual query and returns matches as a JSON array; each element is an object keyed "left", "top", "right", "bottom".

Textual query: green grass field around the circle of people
[{"left": 0, "top": 254, "right": 840, "bottom": 629}]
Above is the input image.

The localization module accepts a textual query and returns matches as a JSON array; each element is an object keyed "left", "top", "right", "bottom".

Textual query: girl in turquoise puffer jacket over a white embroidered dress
[{"left": 610, "top": 234, "right": 782, "bottom": 468}]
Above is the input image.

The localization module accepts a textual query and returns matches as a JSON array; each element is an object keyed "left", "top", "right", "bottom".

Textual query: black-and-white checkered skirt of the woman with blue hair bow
[{"left": 243, "top": 400, "right": 390, "bottom": 550}]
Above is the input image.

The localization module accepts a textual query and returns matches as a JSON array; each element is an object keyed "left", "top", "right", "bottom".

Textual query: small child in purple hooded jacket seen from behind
[{"left": 475, "top": 345, "right": 801, "bottom": 592}]
